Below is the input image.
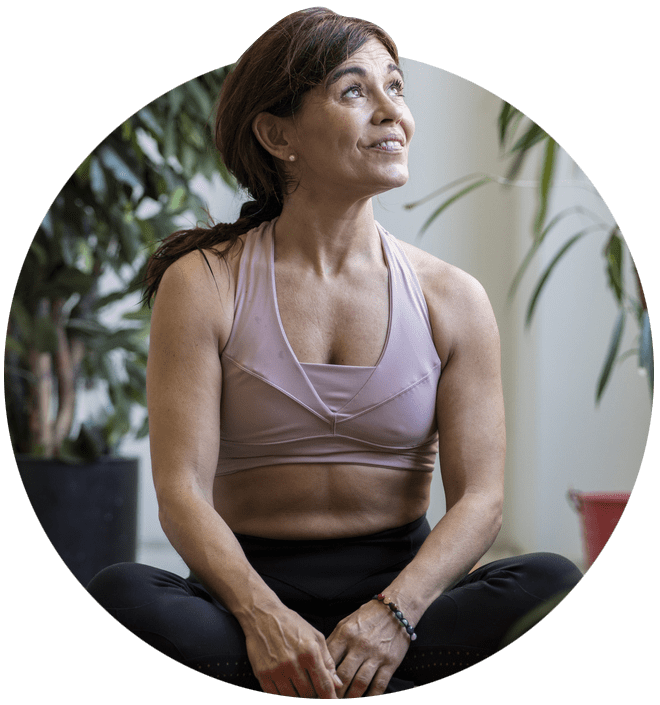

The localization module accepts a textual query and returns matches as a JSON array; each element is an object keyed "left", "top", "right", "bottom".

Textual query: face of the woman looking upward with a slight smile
[{"left": 291, "top": 39, "right": 415, "bottom": 200}]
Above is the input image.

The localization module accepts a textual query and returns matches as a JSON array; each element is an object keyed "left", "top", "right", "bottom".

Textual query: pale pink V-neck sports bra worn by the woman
[{"left": 217, "top": 220, "right": 441, "bottom": 475}]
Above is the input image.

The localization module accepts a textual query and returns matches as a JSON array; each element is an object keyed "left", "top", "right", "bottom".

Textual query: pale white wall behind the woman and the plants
[{"left": 125, "top": 55, "right": 650, "bottom": 567}]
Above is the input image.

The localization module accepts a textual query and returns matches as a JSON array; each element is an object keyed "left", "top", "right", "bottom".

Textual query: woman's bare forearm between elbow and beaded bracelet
[{"left": 382, "top": 493, "right": 502, "bottom": 624}]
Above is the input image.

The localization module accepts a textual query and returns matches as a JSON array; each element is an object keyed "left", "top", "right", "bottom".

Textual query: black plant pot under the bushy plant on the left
[{"left": 16, "top": 455, "right": 138, "bottom": 586}]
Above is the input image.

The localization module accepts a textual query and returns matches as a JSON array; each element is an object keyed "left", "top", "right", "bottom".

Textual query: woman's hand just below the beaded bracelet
[{"left": 327, "top": 600, "right": 410, "bottom": 698}]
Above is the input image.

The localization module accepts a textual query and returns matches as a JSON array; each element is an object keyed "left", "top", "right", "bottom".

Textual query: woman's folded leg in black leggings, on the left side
[{"left": 87, "top": 563, "right": 258, "bottom": 688}]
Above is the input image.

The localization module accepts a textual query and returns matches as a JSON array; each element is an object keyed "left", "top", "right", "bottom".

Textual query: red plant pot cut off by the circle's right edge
[{"left": 568, "top": 490, "right": 630, "bottom": 567}]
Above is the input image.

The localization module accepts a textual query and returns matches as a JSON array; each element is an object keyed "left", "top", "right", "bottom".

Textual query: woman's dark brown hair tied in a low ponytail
[{"left": 145, "top": 7, "right": 399, "bottom": 301}]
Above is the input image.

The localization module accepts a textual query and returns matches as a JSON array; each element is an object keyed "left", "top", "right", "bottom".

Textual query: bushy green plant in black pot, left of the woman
[{"left": 5, "top": 69, "right": 231, "bottom": 584}]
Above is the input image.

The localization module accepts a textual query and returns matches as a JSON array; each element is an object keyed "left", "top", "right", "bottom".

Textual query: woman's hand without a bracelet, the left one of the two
[{"left": 243, "top": 607, "right": 342, "bottom": 699}]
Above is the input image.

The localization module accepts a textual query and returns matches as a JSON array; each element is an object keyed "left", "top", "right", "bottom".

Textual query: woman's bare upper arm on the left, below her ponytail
[{"left": 147, "top": 252, "right": 233, "bottom": 502}]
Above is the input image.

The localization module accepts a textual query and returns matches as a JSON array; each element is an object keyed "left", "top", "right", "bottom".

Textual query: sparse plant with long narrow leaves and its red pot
[{"left": 406, "top": 101, "right": 653, "bottom": 566}]
